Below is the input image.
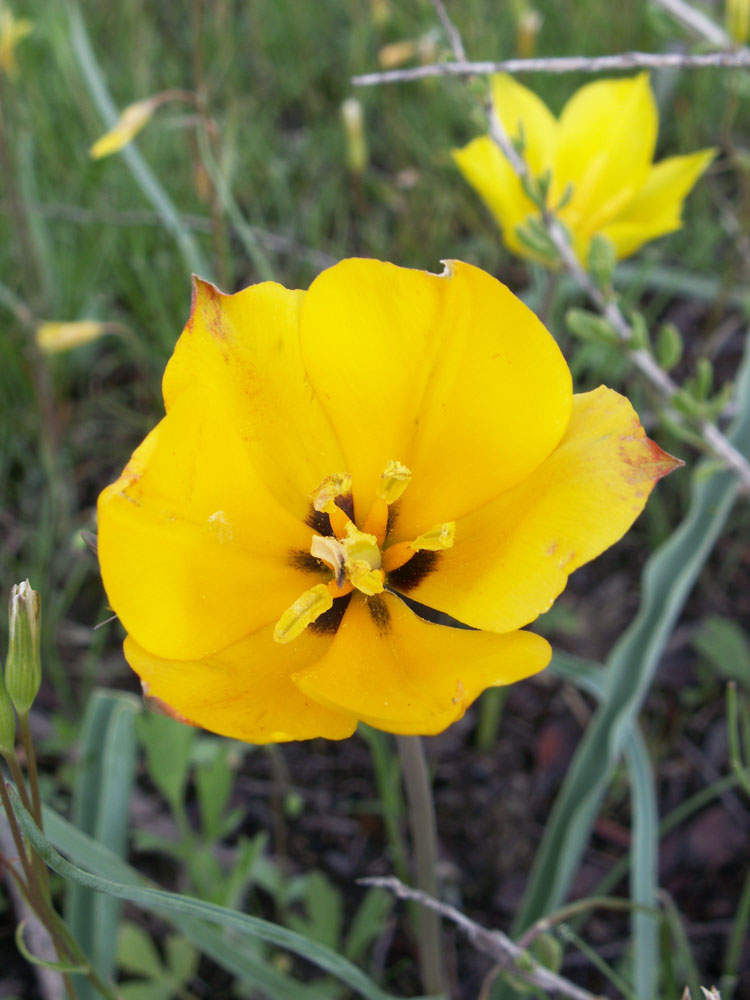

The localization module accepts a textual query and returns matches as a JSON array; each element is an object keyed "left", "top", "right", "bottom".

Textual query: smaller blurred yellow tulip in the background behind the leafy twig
[{"left": 453, "top": 73, "right": 715, "bottom": 264}]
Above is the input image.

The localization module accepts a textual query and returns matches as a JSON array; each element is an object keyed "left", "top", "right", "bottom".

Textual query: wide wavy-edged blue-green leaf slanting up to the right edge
[{"left": 516, "top": 332, "right": 750, "bottom": 930}]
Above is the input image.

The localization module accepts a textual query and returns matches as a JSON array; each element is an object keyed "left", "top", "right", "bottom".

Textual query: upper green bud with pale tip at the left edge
[{"left": 5, "top": 580, "right": 42, "bottom": 717}]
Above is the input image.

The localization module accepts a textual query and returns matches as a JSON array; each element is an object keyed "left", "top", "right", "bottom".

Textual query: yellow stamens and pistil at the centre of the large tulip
[{"left": 273, "top": 460, "right": 456, "bottom": 643}]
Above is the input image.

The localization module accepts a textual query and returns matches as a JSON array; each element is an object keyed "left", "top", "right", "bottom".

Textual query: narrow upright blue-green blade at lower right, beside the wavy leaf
[{"left": 625, "top": 725, "right": 659, "bottom": 1000}]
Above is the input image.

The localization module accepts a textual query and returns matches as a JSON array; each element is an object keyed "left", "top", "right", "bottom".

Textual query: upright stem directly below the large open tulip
[{"left": 396, "top": 736, "right": 447, "bottom": 994}]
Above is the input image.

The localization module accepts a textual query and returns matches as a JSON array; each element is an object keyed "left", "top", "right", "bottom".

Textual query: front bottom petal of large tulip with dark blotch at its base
[{"left": 294, "top": 594, "right": 550, "bottom": 734}]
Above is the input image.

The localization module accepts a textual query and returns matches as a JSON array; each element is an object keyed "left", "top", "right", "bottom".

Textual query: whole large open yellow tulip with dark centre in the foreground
[{"left": 98, "top": 260, "right": 679, "bottom": 743}]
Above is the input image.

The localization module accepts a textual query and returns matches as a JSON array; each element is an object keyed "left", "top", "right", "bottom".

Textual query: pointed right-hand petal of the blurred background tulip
[{"left": 602, "top": 149, "right": 716, "bottom": 258}]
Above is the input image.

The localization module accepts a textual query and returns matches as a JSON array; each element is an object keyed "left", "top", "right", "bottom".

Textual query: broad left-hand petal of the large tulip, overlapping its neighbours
[{"left": 98, "top": 380, "right": 320, "bottom": 659}]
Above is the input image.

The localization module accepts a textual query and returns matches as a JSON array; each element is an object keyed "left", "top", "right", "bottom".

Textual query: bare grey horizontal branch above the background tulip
[{"left": 352, "top": 49, "right": 750, "bottom": 87}]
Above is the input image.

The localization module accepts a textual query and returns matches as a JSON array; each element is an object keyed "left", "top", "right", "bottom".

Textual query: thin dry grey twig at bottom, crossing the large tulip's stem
[{"left": 357, "top": 876, "right": 601, "bottom": 1000}]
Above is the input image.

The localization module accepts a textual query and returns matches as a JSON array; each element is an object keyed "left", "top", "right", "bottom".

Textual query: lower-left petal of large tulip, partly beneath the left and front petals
[{"left": 124, "top": 626, "right": 357, "bottom": 743}]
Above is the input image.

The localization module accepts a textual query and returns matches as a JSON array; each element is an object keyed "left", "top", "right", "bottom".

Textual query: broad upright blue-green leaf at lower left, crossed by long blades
[{"left": 67, "top": 691, "right": 139, "bottom": 1000}]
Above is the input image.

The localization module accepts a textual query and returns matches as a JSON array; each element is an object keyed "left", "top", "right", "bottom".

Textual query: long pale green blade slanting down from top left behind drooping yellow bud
[{"left": 67, "top": 0, "right": 211, "bottom": 278}]
